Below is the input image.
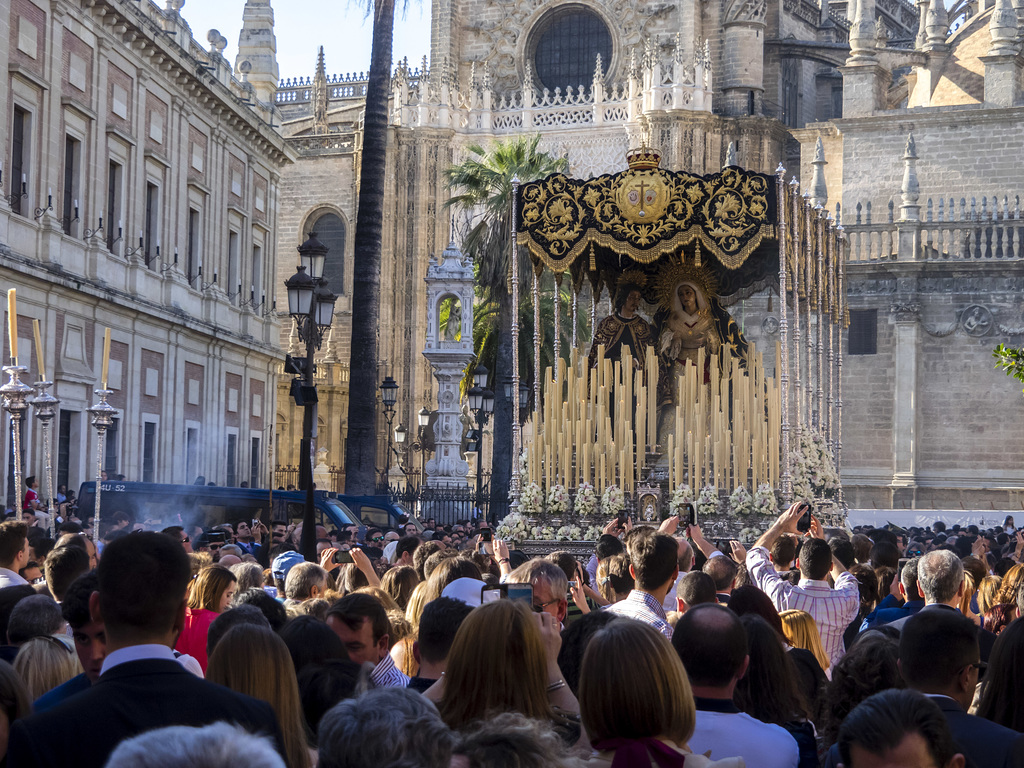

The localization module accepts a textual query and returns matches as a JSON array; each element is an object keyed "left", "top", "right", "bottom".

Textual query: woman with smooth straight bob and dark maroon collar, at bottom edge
[{"left": 580, "top": 621, "right": 744, "bottom": 768}]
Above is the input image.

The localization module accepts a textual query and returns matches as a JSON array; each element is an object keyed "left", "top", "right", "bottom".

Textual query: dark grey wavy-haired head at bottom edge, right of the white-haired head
[{"left": 316, "top": 688, "right": 456, "bottom": 768}]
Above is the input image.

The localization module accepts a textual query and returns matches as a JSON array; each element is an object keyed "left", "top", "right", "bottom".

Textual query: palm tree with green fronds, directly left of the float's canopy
[{"left": 445, "top": 134, "right": 568, "bottom": 514}]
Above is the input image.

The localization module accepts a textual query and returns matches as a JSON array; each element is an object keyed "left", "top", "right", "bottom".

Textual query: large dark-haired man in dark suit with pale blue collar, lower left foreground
[{"left": 7, "top": 534, "right": 281, "bottom": 768}]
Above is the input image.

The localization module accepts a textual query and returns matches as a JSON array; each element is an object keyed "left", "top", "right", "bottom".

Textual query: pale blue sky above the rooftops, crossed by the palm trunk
[{"left": 181, "top": 0, "right": 430, "bottom": 79}]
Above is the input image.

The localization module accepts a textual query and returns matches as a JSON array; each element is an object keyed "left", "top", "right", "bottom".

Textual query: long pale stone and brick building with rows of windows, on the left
[{"left": 0, "top": 0, "right": 295, "bottom": 500}]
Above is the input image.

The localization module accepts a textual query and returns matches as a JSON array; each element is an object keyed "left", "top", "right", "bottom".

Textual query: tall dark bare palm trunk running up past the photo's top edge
[{"left": 345, "top": 0, "right": 394, "bottom": 496}]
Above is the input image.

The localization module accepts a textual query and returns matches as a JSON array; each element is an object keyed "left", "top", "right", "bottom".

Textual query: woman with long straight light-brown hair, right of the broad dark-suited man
[{"left": 206, "top": 625, "right": 316, "bottom": 768}]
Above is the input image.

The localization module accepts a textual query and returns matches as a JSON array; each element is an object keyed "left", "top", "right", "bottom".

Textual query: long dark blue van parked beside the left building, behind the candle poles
[{"left": 78, "top": 480, "right": 359, "bottom": 530}]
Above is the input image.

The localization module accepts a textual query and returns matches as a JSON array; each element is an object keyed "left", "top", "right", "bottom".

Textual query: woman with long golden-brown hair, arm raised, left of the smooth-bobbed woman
[{"left": 424, "top": 600, "right": 581, "bottom": 744}]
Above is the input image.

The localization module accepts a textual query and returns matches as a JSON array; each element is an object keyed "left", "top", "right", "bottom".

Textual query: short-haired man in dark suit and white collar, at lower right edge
[{"left": 899, "top": 610, "right": 1024, "bottom": 768}]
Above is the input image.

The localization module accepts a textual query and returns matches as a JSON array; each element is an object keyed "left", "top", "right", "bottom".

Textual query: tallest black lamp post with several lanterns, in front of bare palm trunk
[{"left": 285, "top": 231, "right": 338, "bottom": 560}]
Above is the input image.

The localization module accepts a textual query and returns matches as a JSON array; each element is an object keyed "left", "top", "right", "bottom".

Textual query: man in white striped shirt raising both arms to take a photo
[{"left": 746, "top": 502, "right": 860, "bottom": 667}]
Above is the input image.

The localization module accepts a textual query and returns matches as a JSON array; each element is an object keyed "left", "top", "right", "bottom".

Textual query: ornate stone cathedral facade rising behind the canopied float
[{"left": 262, "top": 0, "right": 1024, "bottom": 509}]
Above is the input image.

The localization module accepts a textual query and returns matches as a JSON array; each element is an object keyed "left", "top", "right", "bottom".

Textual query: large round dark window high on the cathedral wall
[{"left": 530, "top": 5, "right": 611, "bottom": 93}]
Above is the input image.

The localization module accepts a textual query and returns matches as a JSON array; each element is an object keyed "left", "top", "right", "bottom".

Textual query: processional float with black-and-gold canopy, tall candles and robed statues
[{"left": 505, "top": 146, "right": 848, "bottom": 539}]
